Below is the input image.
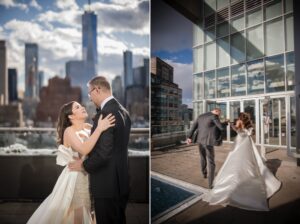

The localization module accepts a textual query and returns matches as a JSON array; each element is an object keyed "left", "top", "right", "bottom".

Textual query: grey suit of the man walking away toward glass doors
[{"left": 188, "top": 112, "right": 224, "bottom": 188}]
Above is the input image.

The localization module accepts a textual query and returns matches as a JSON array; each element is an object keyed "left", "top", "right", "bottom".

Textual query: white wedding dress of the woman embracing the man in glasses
[{"left": 27, "top": 130, "right": 92, "bottom": 224}]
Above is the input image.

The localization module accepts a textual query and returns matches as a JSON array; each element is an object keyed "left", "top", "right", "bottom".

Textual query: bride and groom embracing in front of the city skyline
[{"left": 27, "top": 76, "right": 131, "bottom": 224}]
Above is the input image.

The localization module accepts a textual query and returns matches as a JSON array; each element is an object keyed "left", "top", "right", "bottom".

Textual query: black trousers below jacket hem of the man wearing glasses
[{"left": 94, "top": 196, "right": 128, "bottom": 224}]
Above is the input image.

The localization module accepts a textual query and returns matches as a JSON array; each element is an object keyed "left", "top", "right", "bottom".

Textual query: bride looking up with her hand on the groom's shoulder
[{"left": 27, "top": 101, "right": 115, "bottom": 224}]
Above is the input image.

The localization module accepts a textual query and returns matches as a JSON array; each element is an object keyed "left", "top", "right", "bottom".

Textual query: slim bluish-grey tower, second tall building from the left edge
[{"left": 25, "top": 43, "right": 39, "bottom": 98}]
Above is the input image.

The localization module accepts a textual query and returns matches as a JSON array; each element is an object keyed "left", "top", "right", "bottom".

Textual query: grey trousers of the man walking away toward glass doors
[{"left": 199, "top": 144, "right": 216, "bottom": 188}]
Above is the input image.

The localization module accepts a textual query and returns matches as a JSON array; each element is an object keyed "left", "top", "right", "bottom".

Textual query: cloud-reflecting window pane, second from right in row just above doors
[{"left": 265, "top": 54, "right": 285, "bottom": 93}]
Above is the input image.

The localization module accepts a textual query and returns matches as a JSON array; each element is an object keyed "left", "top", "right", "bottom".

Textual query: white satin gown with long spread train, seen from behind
[{"left": 203, "top": 128, "right": 281, "bottom": 211}]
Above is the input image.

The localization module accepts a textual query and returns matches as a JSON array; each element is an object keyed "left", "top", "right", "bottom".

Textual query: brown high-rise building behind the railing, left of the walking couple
[{"left": 151, "top": 57, "right": 185, "bottom": 147}]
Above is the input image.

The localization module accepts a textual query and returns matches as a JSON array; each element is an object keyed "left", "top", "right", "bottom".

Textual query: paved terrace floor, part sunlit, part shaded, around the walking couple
[{"left": 151, "top": 144, "right": 300, "bottom": 224}]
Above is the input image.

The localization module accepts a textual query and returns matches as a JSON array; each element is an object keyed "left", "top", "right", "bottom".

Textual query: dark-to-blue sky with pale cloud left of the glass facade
[{"left": 151, "top": 0, "right": 193, "bottom": 108}]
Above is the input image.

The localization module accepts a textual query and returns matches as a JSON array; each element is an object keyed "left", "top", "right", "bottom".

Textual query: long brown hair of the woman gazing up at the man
[{"left": 56, "top": 101, "right": 74, "bottom": 145}]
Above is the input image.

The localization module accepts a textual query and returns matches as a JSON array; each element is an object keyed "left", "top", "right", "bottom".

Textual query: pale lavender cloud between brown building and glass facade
[{"left": 164, "top": 60, "right": 193, "bottom": 107}]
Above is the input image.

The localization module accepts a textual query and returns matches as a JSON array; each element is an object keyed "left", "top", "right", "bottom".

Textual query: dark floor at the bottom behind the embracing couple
[{"left": 0, "top": 202, "right": 149, "bottom": 224}]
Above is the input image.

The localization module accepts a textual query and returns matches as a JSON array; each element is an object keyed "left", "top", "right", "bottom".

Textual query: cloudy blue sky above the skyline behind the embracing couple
[{"left": 0, "top": 0, "right": 150, "bottom": 90}]
